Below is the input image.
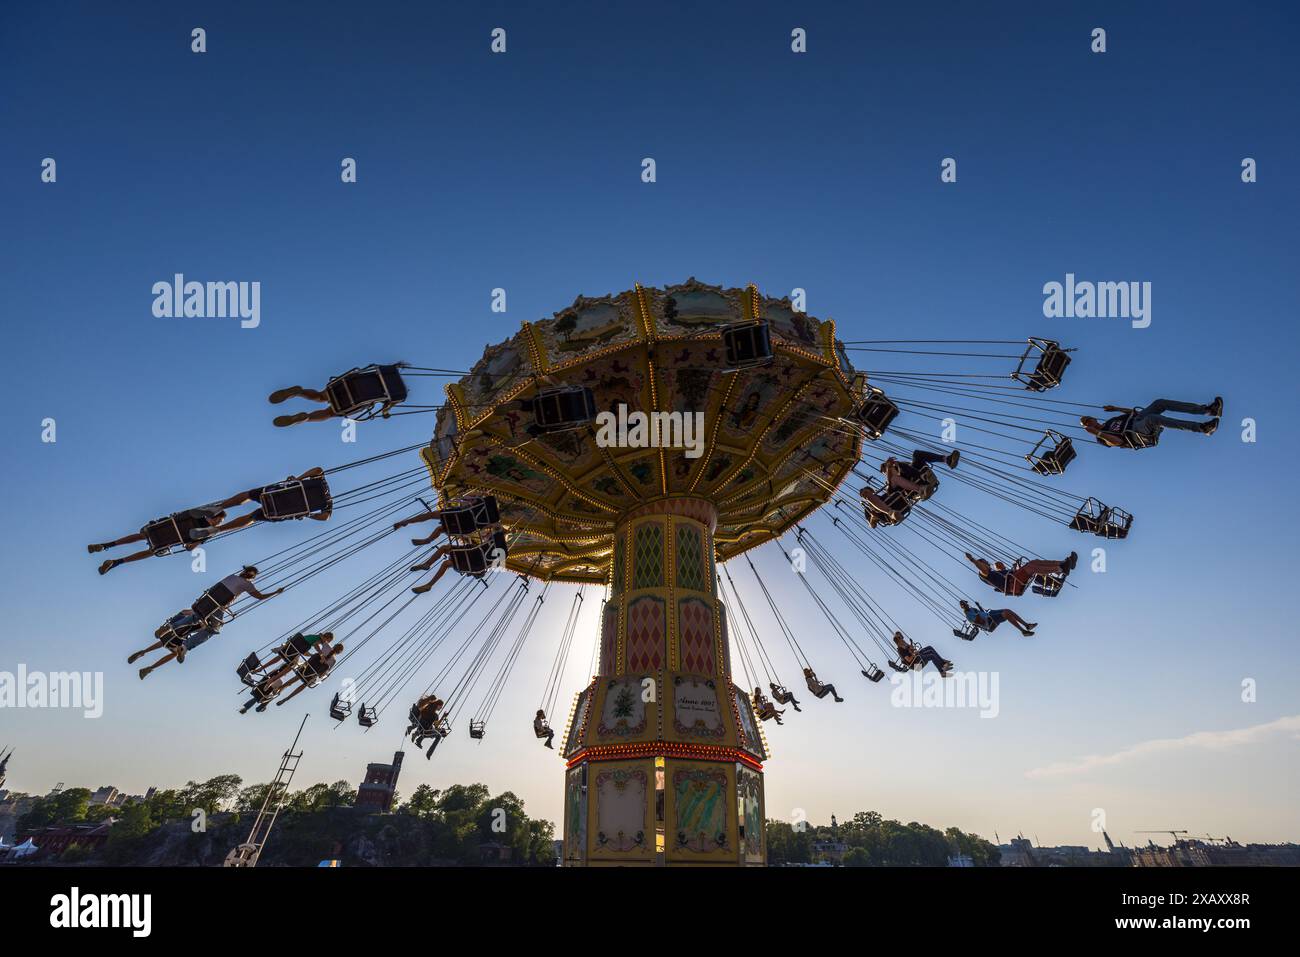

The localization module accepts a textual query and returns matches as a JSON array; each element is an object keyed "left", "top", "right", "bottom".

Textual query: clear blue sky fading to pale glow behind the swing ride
[{"left": 0, "top": 3, "right": 1300, "bottom": 844}]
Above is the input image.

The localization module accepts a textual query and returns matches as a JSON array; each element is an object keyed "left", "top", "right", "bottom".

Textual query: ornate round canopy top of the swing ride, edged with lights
[{"left": 423, "top": 278, "right": 866, "bottom": 581}]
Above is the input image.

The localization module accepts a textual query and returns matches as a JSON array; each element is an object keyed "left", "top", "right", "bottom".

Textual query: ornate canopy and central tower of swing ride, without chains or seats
[{"left": 423, "top": 280, "right": 866, "bottom": 865}]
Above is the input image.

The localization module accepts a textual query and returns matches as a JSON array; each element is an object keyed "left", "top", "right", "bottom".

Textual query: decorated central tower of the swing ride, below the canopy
[{"left": 564, "top": 497, "right": 767, "bottom": 866}]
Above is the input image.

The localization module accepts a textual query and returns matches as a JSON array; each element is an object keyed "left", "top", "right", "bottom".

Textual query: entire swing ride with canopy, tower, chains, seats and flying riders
[{"left": 96, "top": 280, "right": 1223, "bottom": 866}]
